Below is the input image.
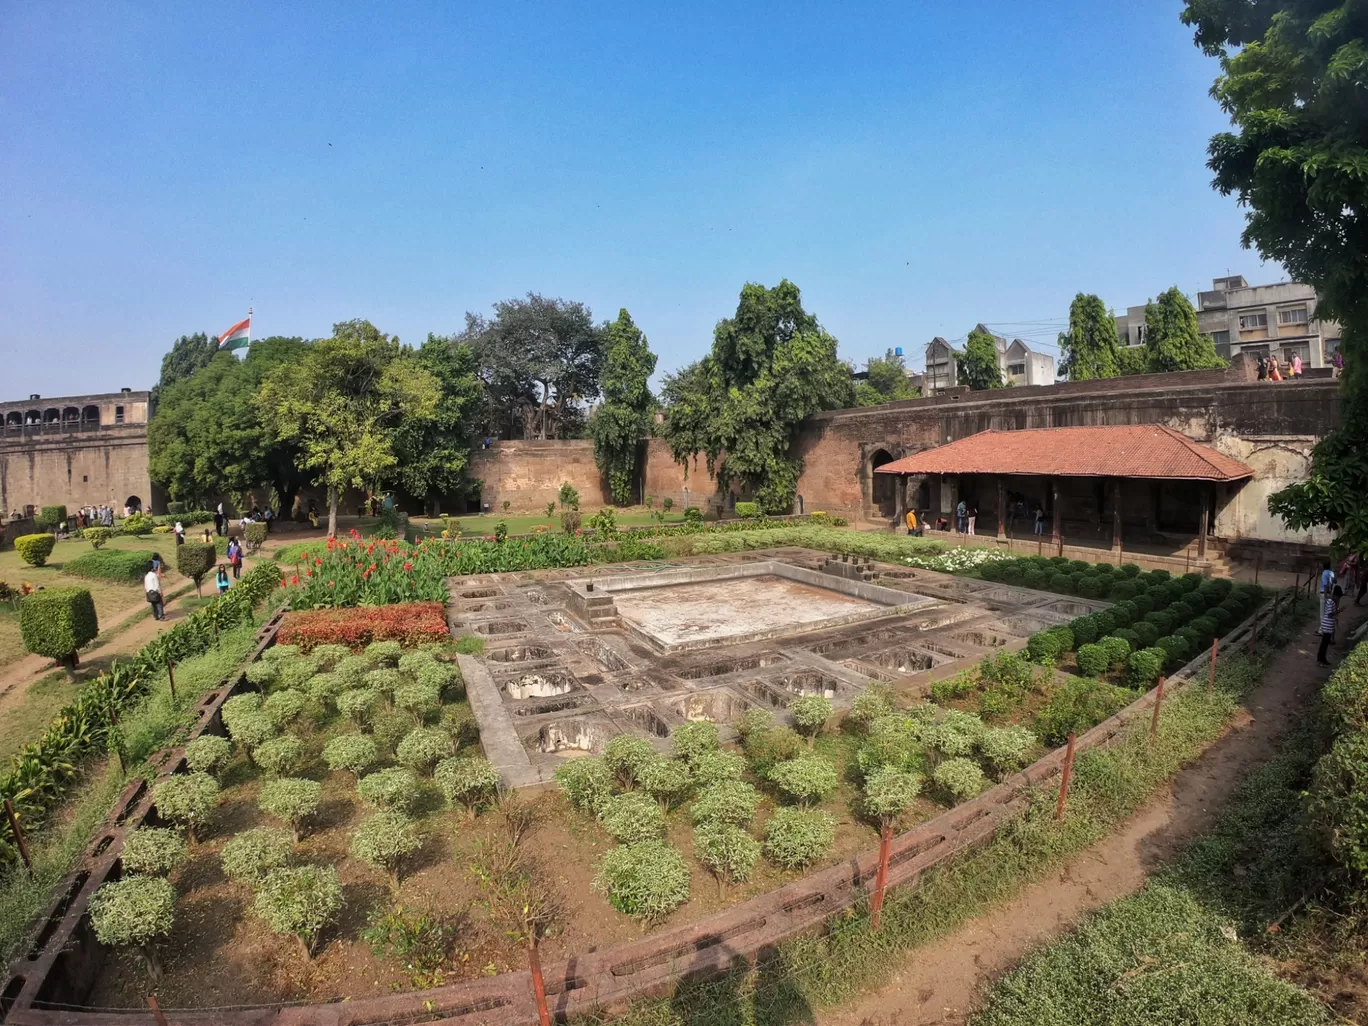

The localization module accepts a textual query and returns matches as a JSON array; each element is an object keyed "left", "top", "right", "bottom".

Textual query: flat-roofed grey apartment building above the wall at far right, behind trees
[{"left": 1116, "top": 275, "right": 1339, "bottom": 367}]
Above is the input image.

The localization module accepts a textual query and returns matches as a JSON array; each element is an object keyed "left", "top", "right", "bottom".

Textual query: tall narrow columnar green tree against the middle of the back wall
[{"left": 590, "top": 309, "right": 655, "bottom": 506}]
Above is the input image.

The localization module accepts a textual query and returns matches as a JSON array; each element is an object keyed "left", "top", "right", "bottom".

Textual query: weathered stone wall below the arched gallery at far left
[{"left": 0, "top": 424, "right": 152, "bottom": 510}]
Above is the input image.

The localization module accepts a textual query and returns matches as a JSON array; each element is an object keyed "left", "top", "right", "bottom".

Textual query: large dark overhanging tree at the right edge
[{"left": 1182, "top": 0, "right": 1368, "bottom": 553}]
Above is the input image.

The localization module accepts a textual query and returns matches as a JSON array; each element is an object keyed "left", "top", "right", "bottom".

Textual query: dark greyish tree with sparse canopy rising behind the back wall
[{"left": 458, "top": 293, "right": 603, "bottom": 438}]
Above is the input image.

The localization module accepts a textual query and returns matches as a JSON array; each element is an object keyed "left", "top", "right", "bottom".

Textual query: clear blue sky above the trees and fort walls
[{"left": 0, "top": 0, "right": 1283, "bottom": 398}]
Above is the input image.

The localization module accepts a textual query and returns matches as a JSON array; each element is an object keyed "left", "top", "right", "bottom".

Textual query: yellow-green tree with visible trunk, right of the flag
[{"left": 257, "top": 320, "right": 442, "bottom": 538}]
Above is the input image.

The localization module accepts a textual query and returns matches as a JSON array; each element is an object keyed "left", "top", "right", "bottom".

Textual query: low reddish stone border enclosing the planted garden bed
[{"left": 0, "top": 595, "right": 1282, "bottom": 1026}]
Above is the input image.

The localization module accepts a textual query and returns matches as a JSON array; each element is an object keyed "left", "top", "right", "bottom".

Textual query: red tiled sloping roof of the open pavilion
[{"left": 874, "top": 424, "right": 1254, "bottom": 482}]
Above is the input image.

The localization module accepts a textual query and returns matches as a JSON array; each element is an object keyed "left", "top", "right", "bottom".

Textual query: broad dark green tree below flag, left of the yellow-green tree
[{"left": 148, "top": 337, "right": 308, "bottom": 514}]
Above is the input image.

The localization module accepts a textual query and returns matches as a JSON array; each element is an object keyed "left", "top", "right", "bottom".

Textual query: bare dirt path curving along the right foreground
[{"left": 818, "top": 607, "right": 1364, "bottom": 1026}]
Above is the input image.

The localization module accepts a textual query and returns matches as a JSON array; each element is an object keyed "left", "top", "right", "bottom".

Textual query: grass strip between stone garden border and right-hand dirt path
[{"left": 582, "top": 603, "right": 1311, "bottom": 1026}]
